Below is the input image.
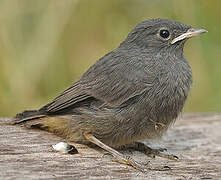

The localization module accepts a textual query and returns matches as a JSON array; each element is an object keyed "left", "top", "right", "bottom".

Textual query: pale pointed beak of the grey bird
[{"left": 171, "top": 28, "right": 208, "bottom": 44}]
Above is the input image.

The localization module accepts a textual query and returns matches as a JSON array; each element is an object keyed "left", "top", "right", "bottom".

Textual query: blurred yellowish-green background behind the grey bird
[{"left": 0, "top": 0, "right": 221, "bottom": 116}]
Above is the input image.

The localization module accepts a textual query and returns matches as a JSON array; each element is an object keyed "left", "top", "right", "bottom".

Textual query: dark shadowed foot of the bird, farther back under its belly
[{"left": 129, "top": 142, "right": 179, "bottom": 160}]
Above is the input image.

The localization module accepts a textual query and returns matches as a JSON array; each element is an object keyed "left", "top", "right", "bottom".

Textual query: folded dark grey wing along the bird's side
[{"left": 42, "top": 52, "right": 153, "bottom": 112}]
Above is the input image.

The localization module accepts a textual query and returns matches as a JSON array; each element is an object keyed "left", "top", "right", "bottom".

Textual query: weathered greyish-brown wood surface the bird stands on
[{"left": 0, "top": 114, "right": 221, "bottom": 180}]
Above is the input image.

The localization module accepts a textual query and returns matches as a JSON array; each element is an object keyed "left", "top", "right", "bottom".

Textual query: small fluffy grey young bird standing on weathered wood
[{"left": 12, "top": 18, "right": 207, "bottom": 172}]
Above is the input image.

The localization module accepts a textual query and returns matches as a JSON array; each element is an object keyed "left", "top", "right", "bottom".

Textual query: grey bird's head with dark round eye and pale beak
[{"left": 121, "top": 19, "right": 207, "bottom": 52}]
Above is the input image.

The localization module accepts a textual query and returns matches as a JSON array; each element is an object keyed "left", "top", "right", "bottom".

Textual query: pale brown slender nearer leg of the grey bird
[{"left": 84, "top": 133, "right": 145, "bottom": 171}]
